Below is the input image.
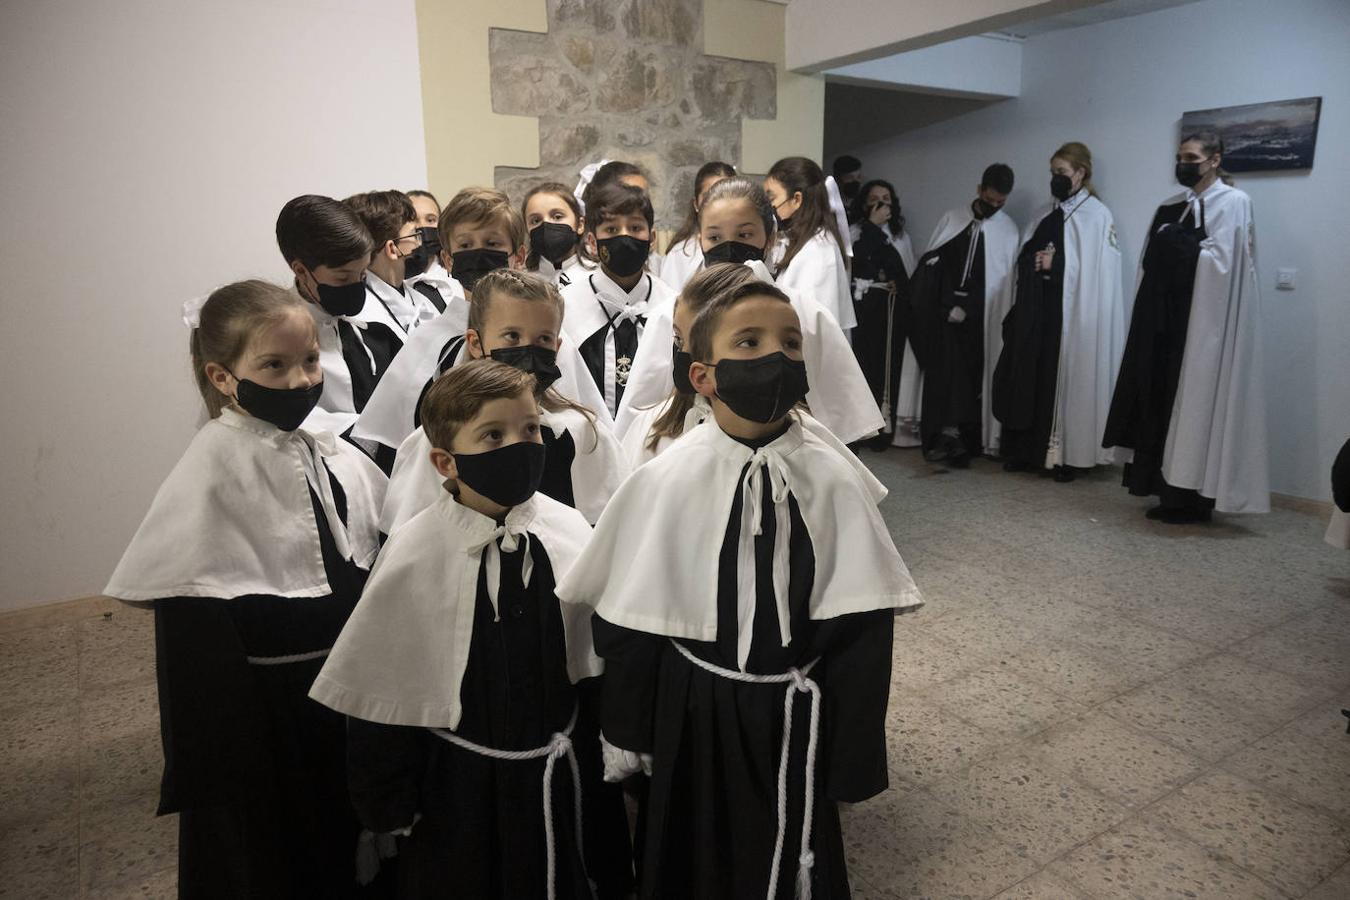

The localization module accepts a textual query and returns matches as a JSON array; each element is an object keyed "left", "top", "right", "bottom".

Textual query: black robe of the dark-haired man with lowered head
[{"left": 910, "top": 227, "right": 984, "bottom": 453}]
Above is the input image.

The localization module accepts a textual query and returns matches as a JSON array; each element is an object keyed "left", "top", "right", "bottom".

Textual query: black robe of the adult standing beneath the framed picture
[{"left": 1102, "top": 201, "right": 1206, "bottom": 497}]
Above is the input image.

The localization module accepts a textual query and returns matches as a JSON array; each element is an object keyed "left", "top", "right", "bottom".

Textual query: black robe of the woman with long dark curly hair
[{"left": 853, "top": 220, "right": 910, "bottom": 430}]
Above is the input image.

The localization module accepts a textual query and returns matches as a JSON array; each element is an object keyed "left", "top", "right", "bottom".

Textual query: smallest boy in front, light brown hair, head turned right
[{"left": 311, "top": 360, "right": 632, "bottom": 900}]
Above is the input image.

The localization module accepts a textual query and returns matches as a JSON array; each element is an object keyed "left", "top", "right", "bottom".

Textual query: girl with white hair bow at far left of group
[{"left": 104, "top": 282, "right": 385, "bottom": 897}]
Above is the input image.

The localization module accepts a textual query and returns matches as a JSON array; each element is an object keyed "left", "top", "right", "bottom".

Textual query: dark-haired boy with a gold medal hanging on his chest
[{"left": 563, "top": 181, "right": 675, "bottom": 420}]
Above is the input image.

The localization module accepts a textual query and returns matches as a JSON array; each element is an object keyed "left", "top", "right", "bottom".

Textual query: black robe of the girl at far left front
[{"left": 155, "top": 476, "right": 385, "bottom": 900}]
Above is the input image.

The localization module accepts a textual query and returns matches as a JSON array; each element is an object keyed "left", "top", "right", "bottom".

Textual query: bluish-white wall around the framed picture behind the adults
[{"left": 826, "top": 0, "right": 1350, "bottom": 499}]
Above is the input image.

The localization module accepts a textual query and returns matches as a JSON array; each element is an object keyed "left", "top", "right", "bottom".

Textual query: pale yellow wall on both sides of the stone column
[{"left": 417, "top": 0, "right": 825, "bottom": 195}]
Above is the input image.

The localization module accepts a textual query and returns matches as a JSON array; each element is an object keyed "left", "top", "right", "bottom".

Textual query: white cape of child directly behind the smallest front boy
[{"left": 379, "top": 409, "right": 628, "bottom": 534}]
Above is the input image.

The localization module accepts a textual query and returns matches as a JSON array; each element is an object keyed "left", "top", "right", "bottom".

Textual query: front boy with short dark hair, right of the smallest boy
[{"left": 556, "top": 282, "right": 922, "bottom": 900}]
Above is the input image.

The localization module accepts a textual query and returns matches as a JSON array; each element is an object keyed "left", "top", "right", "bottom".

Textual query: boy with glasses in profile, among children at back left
[{"left": 343, "top": 190, "right": 446, "bottom": 335}]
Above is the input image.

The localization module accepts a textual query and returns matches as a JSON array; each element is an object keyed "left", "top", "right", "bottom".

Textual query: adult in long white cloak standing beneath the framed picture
[{"left": 1103, "top": 132, "right": 1270, "bottom": 524}]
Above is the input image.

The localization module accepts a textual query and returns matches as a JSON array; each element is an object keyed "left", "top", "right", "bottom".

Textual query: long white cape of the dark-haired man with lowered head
[{"left": 891, "top": 204, "right": 1022, "bottom": 453}]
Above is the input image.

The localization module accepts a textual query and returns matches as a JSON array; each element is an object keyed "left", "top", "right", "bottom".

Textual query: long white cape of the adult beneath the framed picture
[{"left": 1162, "top": 181, "right": 1270, "bottom": 513}]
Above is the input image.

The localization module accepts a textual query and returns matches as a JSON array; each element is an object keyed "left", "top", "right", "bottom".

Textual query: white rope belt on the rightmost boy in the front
[{"left": 671, "top": 640, "right": 821, "bottom": 900}]
